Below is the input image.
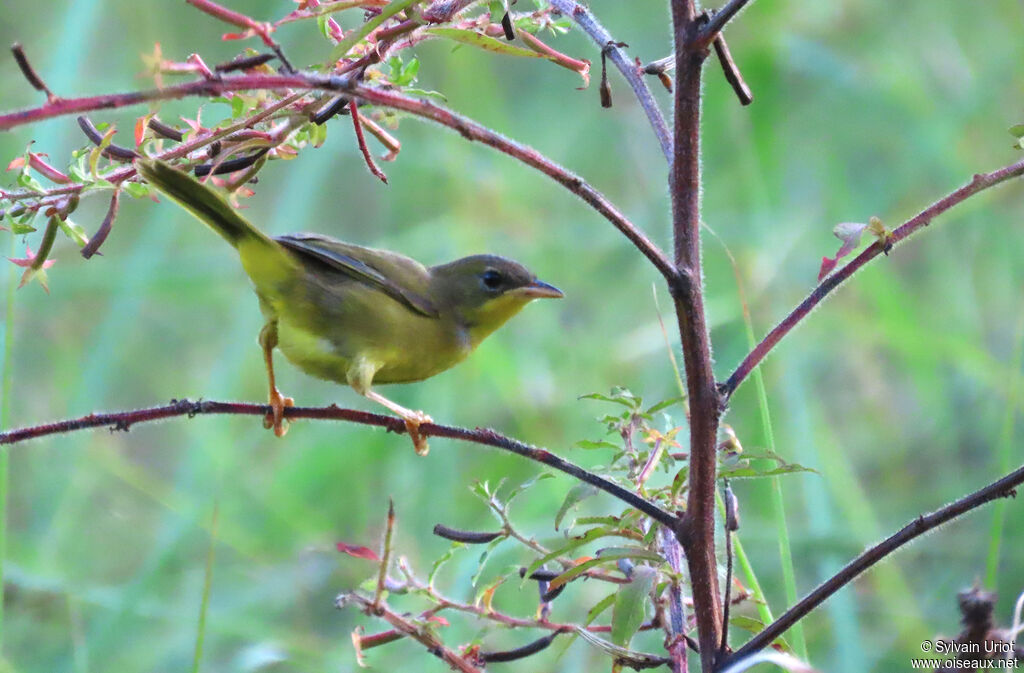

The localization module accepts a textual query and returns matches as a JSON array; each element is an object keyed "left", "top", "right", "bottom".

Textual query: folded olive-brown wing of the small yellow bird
[{"left": 274, "top": 234, "right": 438, "bottom": 318}]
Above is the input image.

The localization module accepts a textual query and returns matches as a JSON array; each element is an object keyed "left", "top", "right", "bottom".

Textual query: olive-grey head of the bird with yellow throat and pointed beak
[{"left": 430, "top": 255, "right": 563, "bottom": 345}]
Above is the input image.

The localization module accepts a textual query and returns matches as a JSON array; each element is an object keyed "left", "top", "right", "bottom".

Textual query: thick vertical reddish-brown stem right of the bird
[{"left": 669, "top": 0, "right": 722, "bottom": 673}]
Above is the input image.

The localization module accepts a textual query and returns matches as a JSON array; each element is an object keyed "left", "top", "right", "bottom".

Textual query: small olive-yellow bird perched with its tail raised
[{"left": 135, "top": 159, "right": 563, "bottom": 455}]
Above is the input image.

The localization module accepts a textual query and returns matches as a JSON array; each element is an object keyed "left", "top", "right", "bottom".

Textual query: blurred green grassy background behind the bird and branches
[{"left": 0, "top": 0, "right": 1024, "bottom": 673}]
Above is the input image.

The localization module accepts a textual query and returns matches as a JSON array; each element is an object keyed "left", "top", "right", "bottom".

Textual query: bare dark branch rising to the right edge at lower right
[{"left": 723, "top": 467, "right": 1024, "bottom": 666}]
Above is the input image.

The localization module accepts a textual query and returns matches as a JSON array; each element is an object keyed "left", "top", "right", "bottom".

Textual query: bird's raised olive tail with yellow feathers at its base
[{"left": 135, "top": 159, "right": 299, "bottom": 295}]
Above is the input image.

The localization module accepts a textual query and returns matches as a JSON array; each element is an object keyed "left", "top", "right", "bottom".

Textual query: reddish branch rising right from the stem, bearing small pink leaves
[{"left": 719, "top": 155, "right": 1024, "bottom": 399}]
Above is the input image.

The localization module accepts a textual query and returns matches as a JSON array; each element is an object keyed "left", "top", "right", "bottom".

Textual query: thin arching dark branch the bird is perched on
[{"left": 0, "top": 399, "right": 677, "bottom": 528}]
